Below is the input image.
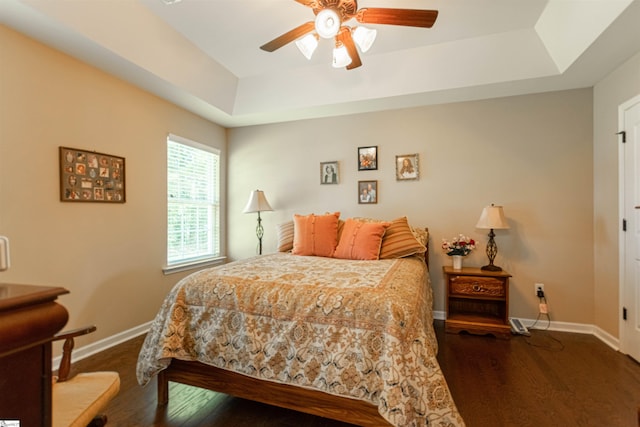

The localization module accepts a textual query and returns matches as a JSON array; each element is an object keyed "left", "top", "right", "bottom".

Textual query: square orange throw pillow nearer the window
[{"left": 291, "top": 212, "right": 340, "bottom": 257}]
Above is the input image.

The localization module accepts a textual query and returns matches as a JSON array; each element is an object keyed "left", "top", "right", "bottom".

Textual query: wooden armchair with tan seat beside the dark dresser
[{"left": 51, "top": 326, "right": 120, "bottom": 427}]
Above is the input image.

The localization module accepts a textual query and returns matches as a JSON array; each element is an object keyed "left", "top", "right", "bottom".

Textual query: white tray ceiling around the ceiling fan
[{"left": 0, "top": 0, "right": 640, "bottom": 127}]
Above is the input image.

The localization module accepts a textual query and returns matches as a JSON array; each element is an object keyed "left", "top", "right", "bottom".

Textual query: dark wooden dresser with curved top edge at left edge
[{"left": 0, "top": 283, "right": 69, "bottom": 427}]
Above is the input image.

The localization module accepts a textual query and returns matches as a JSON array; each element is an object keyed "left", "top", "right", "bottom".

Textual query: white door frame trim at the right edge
[{"left": 617, "top": 94, "right": 640, "bottom": 354}]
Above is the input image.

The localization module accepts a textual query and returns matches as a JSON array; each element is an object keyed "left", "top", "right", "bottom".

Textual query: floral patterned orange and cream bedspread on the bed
[{"left": 137, "top": 253, "right": 464, "bottom": 426}]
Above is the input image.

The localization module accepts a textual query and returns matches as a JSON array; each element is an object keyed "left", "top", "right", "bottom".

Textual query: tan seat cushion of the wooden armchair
[{"left": 51, "top": 372, "right": 120, "bottom": 427}]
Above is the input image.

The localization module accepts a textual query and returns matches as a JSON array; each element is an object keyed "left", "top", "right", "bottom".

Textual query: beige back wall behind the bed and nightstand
[{"left": 228, "top": 89, "right": 594, "bottom": 324}]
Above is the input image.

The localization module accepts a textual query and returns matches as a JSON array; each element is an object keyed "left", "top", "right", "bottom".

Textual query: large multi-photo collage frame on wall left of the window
[{"left": 60, "top": 147, "right": 126, "bottom": 203}]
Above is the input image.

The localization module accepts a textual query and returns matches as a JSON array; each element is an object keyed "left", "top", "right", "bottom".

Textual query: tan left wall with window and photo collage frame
[{"left": 0, "top": 26, "right": 226, "bottom": 352}]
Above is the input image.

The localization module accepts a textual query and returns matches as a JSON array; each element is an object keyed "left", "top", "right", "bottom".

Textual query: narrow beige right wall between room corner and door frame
[{"left": 593, "top": 53, "right": 640, "bottom": 336}]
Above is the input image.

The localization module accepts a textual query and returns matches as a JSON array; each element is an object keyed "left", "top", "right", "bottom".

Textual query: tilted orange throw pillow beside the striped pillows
[{"left": 333, "top": 218, "right": 389, "bottom": 260}]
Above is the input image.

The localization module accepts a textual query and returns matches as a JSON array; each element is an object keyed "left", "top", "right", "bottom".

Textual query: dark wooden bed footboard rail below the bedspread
[{"left": 158, "top": 359, "right": 390, "bottom": 427}]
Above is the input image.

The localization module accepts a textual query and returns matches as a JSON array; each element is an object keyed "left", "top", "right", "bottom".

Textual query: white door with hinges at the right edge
[{"left": 619, "top": 96, "right": 640, "bottom": 361}]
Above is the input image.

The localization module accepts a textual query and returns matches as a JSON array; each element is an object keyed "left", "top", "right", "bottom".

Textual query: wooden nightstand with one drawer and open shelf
[{"left": 442, "top": 266, "right": 511, "bottom": 339}]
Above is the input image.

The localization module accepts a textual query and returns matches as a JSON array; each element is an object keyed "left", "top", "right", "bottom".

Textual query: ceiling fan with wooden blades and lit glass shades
[{"left": 260, "top": 0, "right": 438, "bottom": 70}]
